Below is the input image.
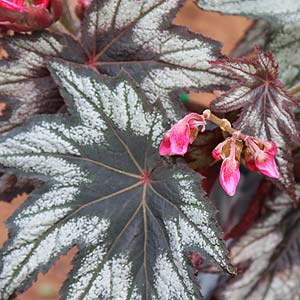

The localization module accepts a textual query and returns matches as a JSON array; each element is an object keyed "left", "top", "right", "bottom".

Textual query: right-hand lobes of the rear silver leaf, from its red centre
[{"left": 82, "top": 0, "right": 229, "bottom": 119}]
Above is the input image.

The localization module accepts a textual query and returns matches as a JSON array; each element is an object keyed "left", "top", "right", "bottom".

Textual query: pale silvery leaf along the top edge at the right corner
[{"left": 197, "top": 0, "right": 300, "bottom": 25}]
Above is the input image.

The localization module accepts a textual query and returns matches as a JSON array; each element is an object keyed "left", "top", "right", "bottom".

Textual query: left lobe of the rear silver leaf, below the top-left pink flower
[{"left": 0, "top": 32, "right": 85, "bottom": 133}]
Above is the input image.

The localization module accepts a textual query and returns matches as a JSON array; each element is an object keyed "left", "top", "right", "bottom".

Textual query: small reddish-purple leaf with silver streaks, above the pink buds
[{"left": 211, "top": 47, "right": 299, "bottom": 199}]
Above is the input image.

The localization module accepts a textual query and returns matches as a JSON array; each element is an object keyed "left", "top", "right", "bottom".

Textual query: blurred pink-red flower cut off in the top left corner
[{"left": 0, "top": 0, "right": 63, "bottom": 31}]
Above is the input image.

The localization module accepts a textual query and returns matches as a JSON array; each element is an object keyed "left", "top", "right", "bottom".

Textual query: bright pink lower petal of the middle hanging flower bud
[{"left": 219, "top": 158, "right": 240, "bottom": 196}]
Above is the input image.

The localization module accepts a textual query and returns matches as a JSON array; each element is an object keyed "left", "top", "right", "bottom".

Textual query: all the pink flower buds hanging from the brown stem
[{"left": 159, "top": 113, "right": 280, "bottom": 196}]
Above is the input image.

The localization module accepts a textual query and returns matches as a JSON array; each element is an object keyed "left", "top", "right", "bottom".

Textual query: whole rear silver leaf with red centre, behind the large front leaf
[{"left": 0, "top": 0, "right": 229, "bottom": 132}]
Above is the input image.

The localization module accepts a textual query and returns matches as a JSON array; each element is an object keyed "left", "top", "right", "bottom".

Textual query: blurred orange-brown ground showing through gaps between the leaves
[{"left": 0, "top": 0, "right": 252, "bottom": 300}]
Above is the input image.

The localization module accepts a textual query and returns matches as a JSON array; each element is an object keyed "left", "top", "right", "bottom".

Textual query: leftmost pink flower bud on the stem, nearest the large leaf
[{"left": 159, "top": 113, "right": 206, "bottom": 155}]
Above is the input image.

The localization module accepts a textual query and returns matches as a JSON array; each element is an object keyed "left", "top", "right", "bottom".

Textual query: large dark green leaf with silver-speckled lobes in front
[{"left": 0, "top": 61, "right": 234, "bottom": 300}]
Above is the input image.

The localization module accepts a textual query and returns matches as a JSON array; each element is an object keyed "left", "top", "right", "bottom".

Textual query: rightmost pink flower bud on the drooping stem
[{"left": 245, "top": 136, "right": 280, "bottom": 178}]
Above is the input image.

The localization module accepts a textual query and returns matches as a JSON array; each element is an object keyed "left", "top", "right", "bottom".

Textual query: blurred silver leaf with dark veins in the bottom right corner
[{"left": 220, "top": 185, "right": 300, "bottom": 300}]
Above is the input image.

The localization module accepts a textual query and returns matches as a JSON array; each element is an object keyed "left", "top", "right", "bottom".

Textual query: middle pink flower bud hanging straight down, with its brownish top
[{"left": 212, "top": 137, "right": 243, "bottom": 196}]
